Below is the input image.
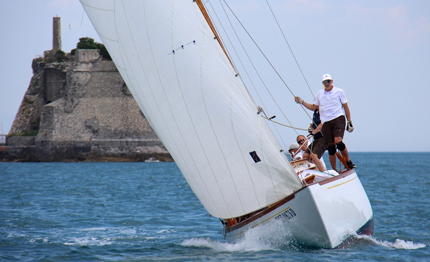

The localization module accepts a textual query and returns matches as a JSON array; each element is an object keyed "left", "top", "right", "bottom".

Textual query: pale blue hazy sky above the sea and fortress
[{"left": 0, "top": 0, "right": 430, "bottom": 152}]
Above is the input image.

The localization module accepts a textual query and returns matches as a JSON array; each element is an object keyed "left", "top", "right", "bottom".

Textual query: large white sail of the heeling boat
[{"left": 80, "top": 0, "right": 301, "bottom": 218}]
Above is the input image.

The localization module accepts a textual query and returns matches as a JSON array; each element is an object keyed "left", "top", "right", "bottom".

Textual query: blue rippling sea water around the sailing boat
[{"left": 0, "top": 153, "right": 430, "bottom": 261}]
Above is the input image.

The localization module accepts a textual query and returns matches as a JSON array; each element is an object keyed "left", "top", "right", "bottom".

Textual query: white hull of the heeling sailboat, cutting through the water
[{"left": 224, "top": 170, "right": 373, "bottom": 248}]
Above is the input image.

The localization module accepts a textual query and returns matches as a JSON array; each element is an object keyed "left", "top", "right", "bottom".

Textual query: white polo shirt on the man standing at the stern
[{"left": 314, "top": 87, "right": 347, "bottom": 124}]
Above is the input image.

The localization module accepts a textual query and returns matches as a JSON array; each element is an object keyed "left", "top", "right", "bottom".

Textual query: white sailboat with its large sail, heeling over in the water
[{"left": 80, "top": 0, "right": 373, "bottom": 248}]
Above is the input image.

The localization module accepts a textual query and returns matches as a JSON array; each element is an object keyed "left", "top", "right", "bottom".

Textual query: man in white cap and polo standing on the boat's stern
[{"left": 294, "top": 74, "right": 355, "bottom": 170}]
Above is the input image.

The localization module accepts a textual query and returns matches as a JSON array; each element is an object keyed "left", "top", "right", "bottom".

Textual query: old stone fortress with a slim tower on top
[{"left": 0, "top": 17, "right": 173, "bottom": 162}]
